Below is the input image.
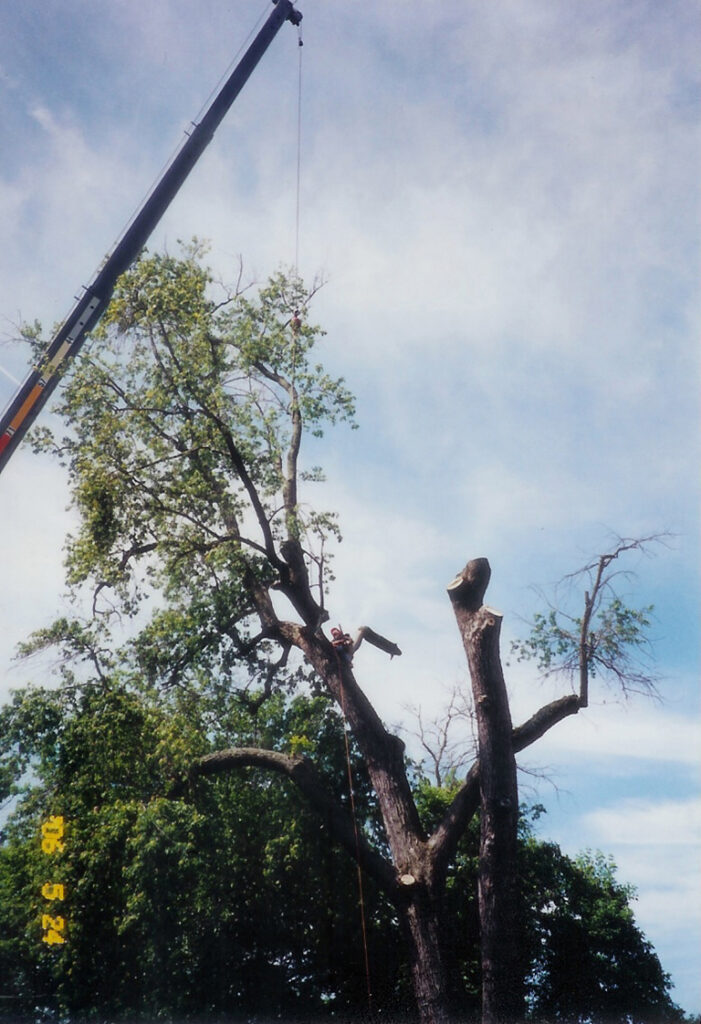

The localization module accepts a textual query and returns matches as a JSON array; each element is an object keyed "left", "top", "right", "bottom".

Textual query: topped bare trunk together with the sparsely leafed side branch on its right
[{"left": 448, "top": 535, "right": 662, "bottom": 1024}]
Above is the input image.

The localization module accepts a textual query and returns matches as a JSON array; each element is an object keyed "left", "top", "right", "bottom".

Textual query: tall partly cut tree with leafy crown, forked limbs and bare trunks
[{"left": 17, "top": 247, "right": 667, "bottom": 1024}]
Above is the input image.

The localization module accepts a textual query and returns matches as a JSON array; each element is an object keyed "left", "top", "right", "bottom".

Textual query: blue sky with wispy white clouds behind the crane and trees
[{"left": 0, "top": 0, "right": 701, "bottom": 1013}]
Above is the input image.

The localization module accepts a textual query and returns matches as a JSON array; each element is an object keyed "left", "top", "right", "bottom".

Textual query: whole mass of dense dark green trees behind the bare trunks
[{"left": 0, "top": 671, "right": 680, "bottom": 1024}]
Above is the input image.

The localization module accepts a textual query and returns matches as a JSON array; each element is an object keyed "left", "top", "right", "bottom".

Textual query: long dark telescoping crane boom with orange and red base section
[{"left": 0, "top": 0, "right": 302, "bottom": 471}]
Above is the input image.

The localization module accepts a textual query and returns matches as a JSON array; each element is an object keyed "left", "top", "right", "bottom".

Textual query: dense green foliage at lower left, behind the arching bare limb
[{"left": 0, "top": 685, "right": 399, "bottom": 1019}]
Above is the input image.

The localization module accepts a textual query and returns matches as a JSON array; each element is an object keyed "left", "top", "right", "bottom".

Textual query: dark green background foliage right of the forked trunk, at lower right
[{"left": 407, "top": 779, "right": 684, "bottom": 1024}]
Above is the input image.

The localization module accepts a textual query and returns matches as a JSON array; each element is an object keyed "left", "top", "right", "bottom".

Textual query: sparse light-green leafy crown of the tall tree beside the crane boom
[{"left": 34, "top": 243, "right": 354, "bottom": 630}]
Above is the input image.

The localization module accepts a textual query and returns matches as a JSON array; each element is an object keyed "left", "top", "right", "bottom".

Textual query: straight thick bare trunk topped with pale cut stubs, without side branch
[{"left": 448, "top": 558, "right": 524, "bottom": 1024}]
